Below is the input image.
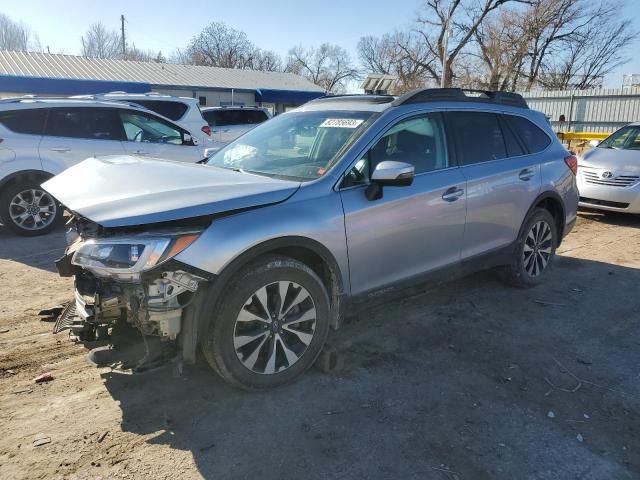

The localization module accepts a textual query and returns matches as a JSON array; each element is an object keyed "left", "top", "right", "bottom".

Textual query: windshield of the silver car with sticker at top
[{"left": 207, "top": 111, "right": 372, "bottom": 181}]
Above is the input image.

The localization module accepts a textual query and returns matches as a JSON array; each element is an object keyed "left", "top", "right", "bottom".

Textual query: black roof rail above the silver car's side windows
[{"left": 393, "top": 88, "right": 529, "bottom": 108}]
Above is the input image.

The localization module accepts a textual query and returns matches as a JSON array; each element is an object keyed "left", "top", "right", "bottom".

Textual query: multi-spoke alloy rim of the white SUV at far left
[{"left": 9, "top": 188, "right": 58, "bottom": 230}]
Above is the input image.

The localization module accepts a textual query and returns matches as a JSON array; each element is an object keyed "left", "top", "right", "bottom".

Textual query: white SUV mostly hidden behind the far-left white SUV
[{"left": 74, "top": 92, "right": 215, "bottom": 148}]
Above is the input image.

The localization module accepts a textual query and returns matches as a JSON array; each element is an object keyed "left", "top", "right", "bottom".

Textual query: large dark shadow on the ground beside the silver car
[{"left": 97, "top": 257, "right": 640, "bottom": 480}]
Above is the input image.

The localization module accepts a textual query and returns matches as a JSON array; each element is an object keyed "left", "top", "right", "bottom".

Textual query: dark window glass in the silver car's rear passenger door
[{"left": 447, "top": 112, "right": 507, "bottom": 165}]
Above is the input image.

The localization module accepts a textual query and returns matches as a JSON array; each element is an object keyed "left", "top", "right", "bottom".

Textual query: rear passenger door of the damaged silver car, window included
[{"left": 446, "top": 110, "right": 541, "bottom": 259}]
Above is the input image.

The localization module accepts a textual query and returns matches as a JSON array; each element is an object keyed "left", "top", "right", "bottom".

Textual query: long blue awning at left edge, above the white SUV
[{"left": 0, "top": 75, "right": 151, "bottom": 95}]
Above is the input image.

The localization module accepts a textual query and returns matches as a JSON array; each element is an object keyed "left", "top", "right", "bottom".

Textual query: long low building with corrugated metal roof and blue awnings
[{"left": 0, "top": 51, "right": 324, "bottom": 112}]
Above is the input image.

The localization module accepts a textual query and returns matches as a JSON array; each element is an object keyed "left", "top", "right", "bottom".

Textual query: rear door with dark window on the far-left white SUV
[{"left": 39, "top": 107, "right": 125, "bottom": 171}]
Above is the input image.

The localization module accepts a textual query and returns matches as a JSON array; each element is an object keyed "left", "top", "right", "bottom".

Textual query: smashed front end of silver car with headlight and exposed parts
[{"left": 54, "top": 217, "right": 209, "bottom": 372}]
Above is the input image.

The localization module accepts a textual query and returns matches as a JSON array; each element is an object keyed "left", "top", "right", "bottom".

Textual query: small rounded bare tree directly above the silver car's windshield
[{"left": 286, "top": 43, "right": 358, "bottom": 93}]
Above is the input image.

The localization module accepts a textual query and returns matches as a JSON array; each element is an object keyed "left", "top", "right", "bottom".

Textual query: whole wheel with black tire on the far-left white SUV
[{"left": 0, "top": 180, "right": 64, "bottom": 237}]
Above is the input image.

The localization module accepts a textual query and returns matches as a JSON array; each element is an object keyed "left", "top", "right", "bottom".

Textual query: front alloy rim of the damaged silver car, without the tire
[{"left": 233, "top": 280, "right": 316, "bottom": 375}]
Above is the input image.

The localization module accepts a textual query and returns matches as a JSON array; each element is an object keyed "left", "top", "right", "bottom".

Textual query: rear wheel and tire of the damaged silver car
[{"left": 501, "top": 208, "right": 558, "bottom": 288}]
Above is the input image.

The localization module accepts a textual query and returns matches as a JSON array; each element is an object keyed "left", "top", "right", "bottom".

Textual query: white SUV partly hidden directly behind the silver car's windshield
[{"left": 202, "top": 107, "right": 271, "bottom": 144}]
